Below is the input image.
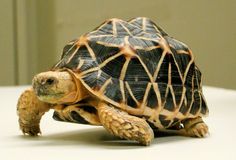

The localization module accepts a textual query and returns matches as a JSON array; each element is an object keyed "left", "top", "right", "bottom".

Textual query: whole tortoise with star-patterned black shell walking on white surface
[{"left": 17, "top": 17, "right": 209, "bottom": 145}]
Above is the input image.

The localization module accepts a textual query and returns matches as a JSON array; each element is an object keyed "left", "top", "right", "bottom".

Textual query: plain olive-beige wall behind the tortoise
[{"left": 0, "top": 0, "right": 236, "bottom": 89}]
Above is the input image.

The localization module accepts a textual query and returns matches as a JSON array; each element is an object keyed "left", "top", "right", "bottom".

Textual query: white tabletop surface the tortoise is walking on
[{"left": 0, "top": 86, "right": 236, "bottom": 160}]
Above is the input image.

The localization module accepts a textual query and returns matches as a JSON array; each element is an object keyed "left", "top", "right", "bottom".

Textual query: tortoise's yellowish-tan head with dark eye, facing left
[{"left": 32, "top": 71, "right": 85, "bottom": 104}]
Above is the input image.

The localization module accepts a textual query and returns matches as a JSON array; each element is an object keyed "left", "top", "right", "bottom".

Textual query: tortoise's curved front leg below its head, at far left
[{"left": 17, "top": 88, "right": 51, "bottom": 136}]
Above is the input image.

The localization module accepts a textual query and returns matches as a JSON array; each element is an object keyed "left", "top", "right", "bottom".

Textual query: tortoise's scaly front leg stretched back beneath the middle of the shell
[{"left": 98, "top": 102, "right": 154, "bottom": 145}]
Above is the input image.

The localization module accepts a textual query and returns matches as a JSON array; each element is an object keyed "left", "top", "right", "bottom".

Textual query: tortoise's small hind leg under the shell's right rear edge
[{"left": 182, "top": 117, "right": 208, "bottom": 138}]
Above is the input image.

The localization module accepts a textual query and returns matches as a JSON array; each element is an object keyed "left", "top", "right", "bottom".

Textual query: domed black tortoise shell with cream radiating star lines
[{"left": 53, "top": 17, "right": 208, "bottom": 128}]
